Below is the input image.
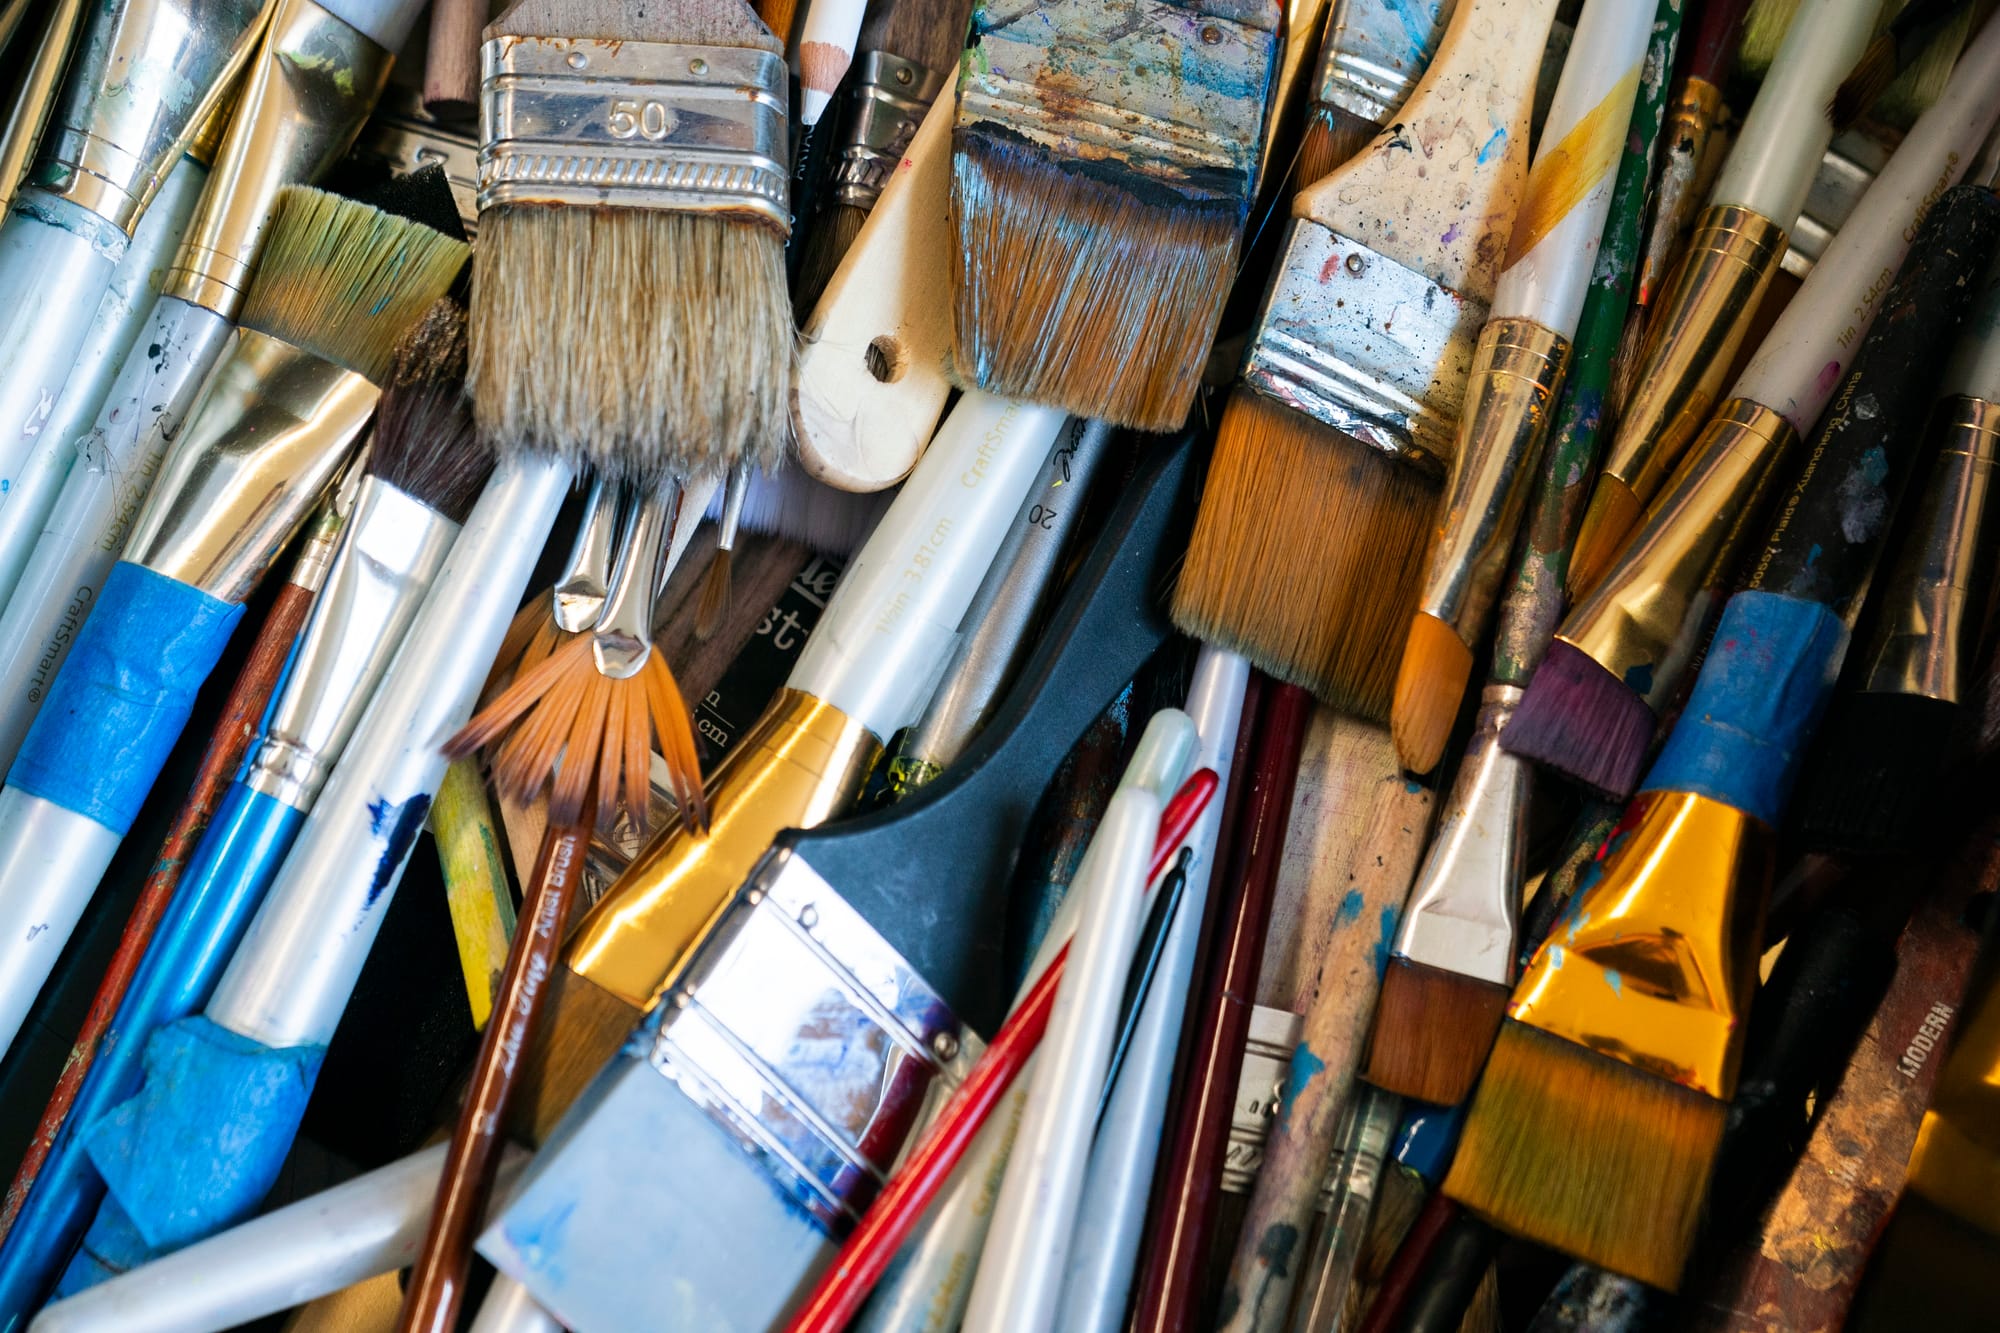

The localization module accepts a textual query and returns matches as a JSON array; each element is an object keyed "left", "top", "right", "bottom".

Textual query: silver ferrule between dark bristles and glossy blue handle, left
[{"left": 242, "top": 476, "right": 458, "bottom": 811}]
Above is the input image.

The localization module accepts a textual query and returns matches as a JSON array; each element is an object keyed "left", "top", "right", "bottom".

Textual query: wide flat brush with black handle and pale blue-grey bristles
[{"left": 480, "top": 438, "right": 1190, "bottom": 1329}]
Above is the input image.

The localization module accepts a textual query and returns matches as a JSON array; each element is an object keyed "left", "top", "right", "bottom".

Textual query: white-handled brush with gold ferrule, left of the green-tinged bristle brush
[{"left": 0, "top": 0, "right": 418, "bottom": 763}]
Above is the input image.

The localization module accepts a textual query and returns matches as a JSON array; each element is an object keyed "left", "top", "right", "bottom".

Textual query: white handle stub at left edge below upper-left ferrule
[{"left": 0, "top": 202, "right": 126, "bottom": 498}]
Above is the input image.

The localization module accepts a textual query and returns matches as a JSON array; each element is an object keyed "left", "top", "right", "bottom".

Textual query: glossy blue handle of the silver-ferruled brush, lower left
[{"left": 0, "top": 783, "right": 306, "bottom": 1312}]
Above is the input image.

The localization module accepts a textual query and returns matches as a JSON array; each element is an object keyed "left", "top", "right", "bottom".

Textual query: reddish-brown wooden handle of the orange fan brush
[{"left": 396, "top": 825, "right": 590, "bottom": 1333}]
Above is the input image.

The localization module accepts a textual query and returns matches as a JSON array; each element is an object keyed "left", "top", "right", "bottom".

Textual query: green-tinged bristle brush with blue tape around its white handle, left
[{"left": 0, "top": 176, "right": 466, "bottom": 1072}]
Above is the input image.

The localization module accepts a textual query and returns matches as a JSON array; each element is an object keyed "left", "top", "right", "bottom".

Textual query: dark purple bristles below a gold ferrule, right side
[{"left": 1500, "top": 638, "right": 1656, "bottom": 801}]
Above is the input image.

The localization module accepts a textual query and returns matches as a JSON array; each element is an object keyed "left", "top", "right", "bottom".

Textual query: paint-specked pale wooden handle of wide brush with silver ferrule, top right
[{"left": 1292, "top": 0, "right": 1556, "bottom": 302}]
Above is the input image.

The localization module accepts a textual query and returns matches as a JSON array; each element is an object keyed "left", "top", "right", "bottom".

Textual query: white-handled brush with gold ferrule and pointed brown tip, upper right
[{"left": 1570, "top": 0, "right": 1880, "bottom": 598}]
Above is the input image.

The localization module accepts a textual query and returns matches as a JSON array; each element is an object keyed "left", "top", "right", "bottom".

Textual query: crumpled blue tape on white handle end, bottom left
[{"left": 84, "top": 1015, "right": 326, "bottom": 1253}]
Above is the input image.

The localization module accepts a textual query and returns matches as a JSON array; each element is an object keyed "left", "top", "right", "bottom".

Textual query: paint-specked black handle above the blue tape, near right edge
[{"left": 1750, "top": 186, "right": 2000, "bottom": 626}]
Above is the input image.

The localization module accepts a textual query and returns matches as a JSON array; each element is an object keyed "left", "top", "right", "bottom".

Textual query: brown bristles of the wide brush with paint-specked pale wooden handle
[{"left": 1174, "top": 388, "right": 1440, "bottom": 723}]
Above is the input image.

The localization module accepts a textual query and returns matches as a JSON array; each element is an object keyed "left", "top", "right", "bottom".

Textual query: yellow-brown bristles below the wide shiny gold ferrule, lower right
[{"left": 1444, "top": 1023, "right": 1728, "bottom": 1291}]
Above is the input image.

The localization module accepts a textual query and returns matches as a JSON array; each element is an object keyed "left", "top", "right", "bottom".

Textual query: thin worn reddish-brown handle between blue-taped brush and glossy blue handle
[{"left": 0, "top": 582, "right": 314, "bottom": 1235}]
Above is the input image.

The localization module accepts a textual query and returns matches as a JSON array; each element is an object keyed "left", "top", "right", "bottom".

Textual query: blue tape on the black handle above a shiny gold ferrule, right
[{"left": 1640, "top": 592, "right": 1848, "bottom": 827}]
